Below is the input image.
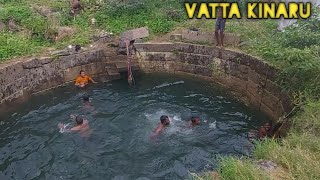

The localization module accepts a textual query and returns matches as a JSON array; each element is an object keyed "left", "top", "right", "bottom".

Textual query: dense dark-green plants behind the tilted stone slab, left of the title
[{"left": 96, "top": 0, "right": 183, "bottom": 34}]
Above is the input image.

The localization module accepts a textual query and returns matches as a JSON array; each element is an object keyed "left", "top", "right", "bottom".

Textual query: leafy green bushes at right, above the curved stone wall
[{"left": 227, "top": 12, "right": 320, "bottom": 98}]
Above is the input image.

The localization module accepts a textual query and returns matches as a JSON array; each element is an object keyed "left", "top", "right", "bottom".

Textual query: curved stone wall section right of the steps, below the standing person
[{"left": 135, "top": 43, "right": 292, "bottom": 120}]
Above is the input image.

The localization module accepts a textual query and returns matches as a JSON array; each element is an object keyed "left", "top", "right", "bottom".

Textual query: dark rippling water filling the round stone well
[{"left": 0, "top": 74, "right": 267, "bottom": 179}]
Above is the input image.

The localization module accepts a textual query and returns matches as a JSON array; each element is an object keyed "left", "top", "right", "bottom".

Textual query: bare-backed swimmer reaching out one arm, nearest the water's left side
[{"left": 58, "top": 116, "right": 91, "bottom": 137}]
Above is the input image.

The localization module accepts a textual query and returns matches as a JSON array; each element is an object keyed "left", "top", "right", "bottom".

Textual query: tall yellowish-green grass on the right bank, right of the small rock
[{"left": 255, "top": 101, "right": 320, "bottom": 179}]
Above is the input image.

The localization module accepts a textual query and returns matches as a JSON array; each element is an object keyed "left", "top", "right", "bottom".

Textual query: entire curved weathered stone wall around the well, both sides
[{"left": 0, "top": 43, "right": 292, "bottom": 119}]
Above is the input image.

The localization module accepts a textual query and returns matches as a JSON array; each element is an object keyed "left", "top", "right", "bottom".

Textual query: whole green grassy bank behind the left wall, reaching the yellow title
[{"left": 0, "top": 0, "right": 187, "bottom": 62}]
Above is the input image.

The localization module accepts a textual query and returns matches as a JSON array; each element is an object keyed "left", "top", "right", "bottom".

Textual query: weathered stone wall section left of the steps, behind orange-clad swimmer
[{"left": 0, "top": 49, "right": 134, "bottom": 107}]
